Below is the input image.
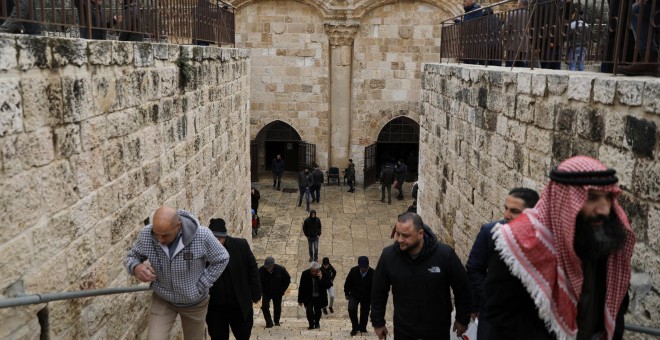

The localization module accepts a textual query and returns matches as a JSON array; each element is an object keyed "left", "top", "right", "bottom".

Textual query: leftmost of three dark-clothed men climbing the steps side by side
[{"left": 259, "top": 256, "right": 291, "bottom": 328}]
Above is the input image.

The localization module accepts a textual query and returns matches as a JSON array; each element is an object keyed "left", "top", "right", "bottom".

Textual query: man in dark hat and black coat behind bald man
[{"left": 206, "top": 218, "right": 261, "bottom": 340}]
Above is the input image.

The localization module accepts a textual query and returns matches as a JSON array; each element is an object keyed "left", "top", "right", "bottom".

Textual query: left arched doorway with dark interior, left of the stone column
[{"left": 250, "top": 120, "right": 316, "bottom": 181}]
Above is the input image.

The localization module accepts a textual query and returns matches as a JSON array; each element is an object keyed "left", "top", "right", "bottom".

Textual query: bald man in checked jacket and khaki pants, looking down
[{"left": 126, "top": 207, "right": 229, "bottom": 340}]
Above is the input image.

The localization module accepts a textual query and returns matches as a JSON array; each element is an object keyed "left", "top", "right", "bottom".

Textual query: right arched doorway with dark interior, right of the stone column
[{"left": 365, "top": 116, "right": 419, "bottom": 184}]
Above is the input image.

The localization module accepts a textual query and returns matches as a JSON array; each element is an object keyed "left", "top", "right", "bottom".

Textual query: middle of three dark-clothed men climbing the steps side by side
[{"left": 298, "top": 262, "right": 332, "bottom": 329}]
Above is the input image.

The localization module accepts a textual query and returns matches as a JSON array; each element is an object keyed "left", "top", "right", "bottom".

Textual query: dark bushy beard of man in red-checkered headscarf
[{"left": 573, "top": 213, "right": 626, "bottom": 260}]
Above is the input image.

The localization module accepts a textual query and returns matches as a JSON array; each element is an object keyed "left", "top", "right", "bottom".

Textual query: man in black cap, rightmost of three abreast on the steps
[{"left": 344, "top": 256, "right": 374, "bottom": 336}]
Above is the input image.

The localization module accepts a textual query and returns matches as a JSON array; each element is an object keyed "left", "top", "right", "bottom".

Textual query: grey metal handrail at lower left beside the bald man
[{"left": 0, "top": 286, "right": 151, "bottom": 309}]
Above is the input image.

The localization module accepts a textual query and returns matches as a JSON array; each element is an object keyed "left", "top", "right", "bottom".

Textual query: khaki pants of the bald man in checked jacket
[{"left": 148, "top": 293, "right": 209, "bottom": 340}]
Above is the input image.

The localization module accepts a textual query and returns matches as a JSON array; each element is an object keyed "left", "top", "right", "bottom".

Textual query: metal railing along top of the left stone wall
[{"left": 0, "top": 0, "right": 235, "bottom": 45}]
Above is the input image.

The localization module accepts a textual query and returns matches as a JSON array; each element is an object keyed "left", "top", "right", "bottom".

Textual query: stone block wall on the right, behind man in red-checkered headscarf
[{"left": 418, "top": 64, "right": 660, "bottom": 328}]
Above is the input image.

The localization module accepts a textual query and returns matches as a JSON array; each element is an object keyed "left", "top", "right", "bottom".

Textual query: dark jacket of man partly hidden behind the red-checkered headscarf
[{"left": 465, "top": 220, "right": 505, "bottom": 313}]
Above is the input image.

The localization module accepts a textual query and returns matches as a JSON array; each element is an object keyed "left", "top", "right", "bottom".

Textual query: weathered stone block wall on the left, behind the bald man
[{"left": 0, "top": 35, "right": 250, "bottom": 339}]
